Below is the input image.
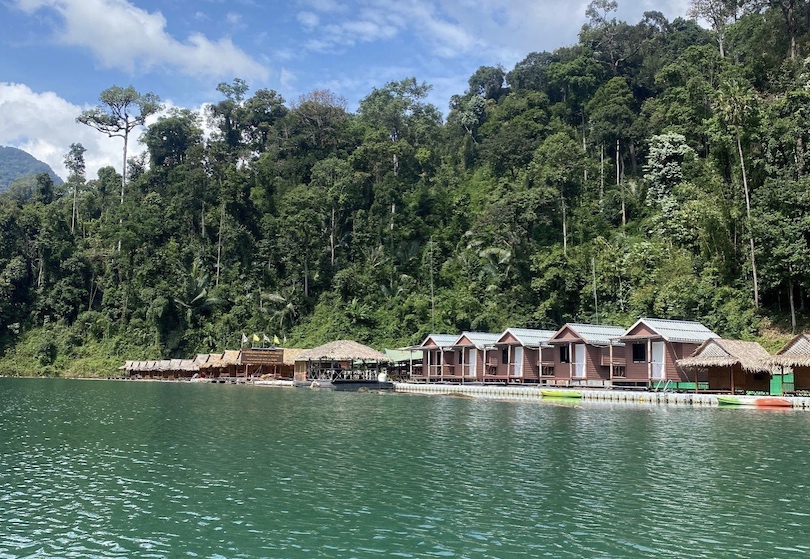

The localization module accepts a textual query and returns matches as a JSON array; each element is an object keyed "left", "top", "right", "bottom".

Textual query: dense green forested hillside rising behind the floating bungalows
[{"left": 0, "top": 0, "right": 810, "bottom": 373}]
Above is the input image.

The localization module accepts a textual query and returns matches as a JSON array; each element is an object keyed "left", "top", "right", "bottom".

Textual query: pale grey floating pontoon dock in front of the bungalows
[{"left": 394, "top": 382, "right": 810, "bottom": 410}]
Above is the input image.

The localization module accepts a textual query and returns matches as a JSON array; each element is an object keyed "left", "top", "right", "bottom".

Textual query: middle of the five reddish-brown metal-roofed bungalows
[{"left": 484, "top": 328, "right": 554, "bottom": 383}]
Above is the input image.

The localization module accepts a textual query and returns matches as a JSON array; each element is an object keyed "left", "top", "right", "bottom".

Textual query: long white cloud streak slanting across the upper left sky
[{"left": 17, "top": 0, "right": 269, "bottom": 80}]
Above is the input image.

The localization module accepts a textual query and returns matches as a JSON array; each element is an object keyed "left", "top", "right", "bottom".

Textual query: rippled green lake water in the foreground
[{"left": 0, "top": 379, "right": 810, "bottom": 559}]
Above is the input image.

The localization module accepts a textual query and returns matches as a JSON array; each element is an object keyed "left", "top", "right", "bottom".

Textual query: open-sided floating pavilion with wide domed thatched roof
[{"left": 295, "top": 340, "right": 393, "bottom": 388}]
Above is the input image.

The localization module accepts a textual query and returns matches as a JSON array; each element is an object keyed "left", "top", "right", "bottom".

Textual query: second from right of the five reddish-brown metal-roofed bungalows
[{"left": 540, "top": 324, "right": 624, "bottom": 388}]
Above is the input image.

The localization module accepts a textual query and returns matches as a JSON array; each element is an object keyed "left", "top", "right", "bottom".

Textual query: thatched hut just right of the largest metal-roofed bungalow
[{"left": 678, "top": 338, "right": 772, "bottom": 394}]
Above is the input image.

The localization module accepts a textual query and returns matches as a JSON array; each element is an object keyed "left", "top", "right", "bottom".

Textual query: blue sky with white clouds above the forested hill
[{"left": 0, "top": 0, "right": 689, "bottom": 178}]
